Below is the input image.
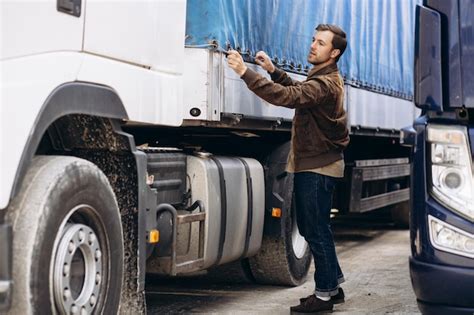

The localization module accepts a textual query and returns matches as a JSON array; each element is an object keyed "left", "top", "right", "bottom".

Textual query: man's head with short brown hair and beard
[{"left": 308, "top": 24, "right": 347, "bottom": 66}]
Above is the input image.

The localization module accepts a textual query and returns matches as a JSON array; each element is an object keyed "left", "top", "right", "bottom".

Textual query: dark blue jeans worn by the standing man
[{"left": 294, "top": 172, "right": 344, "bottom": 297}]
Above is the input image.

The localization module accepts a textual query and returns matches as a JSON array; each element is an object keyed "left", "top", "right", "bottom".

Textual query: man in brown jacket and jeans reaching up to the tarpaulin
[{"left": 227, "top": 24, "right": 349, "bottom": 314}]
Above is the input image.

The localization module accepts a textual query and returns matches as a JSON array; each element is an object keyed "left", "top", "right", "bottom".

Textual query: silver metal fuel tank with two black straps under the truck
[{"left": 185, "top": 155, "right": 265, "bottom": 268}]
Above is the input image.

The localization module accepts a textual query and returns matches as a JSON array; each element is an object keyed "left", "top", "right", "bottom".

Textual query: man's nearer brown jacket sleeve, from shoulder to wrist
[{"left": 242, "top": 69, "right": 331, "bottom": 108}]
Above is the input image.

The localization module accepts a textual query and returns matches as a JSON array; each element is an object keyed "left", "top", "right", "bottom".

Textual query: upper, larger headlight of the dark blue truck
[{"left": 427, "top": 125, "right": 474, "bottom": 221}]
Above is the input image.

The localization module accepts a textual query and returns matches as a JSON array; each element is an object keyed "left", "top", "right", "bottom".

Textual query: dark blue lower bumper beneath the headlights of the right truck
[{"left": 410, "top": 257, "right": 474, "bottom": 315}]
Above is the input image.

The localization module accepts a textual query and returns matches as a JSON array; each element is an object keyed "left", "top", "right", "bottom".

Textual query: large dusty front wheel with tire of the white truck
[{"left": 7, "top": 156, "right": 124, "bottom": 314}]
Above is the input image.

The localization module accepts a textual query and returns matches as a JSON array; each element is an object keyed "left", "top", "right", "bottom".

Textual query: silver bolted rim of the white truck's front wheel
[{"left": 52, "top": 207, "right": 103, "bottom": 314}]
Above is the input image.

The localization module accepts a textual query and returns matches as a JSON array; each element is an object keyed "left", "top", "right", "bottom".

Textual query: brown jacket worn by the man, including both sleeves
[{"left": 242, "top": 64, "right": 349, "bottom": 171}]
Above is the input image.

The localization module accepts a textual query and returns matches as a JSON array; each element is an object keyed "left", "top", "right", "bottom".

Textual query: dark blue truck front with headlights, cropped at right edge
[{"left": 408, "top": 0, "right": 474, "bottom": 314}]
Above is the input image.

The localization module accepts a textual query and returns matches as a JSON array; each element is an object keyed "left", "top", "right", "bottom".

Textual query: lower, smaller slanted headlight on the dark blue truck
[{"left": 428, "top": 215, "right": 474, "bottom": 258}]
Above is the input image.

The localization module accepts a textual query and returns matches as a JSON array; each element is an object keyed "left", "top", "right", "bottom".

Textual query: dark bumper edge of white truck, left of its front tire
[{"left": 0, "top": 223, "right": 12, "bottom": 313}]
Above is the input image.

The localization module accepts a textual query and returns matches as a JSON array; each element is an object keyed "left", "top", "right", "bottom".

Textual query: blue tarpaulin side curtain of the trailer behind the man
[{"left": 186, "top": 0, "right": 421, "bottom": 100}]
